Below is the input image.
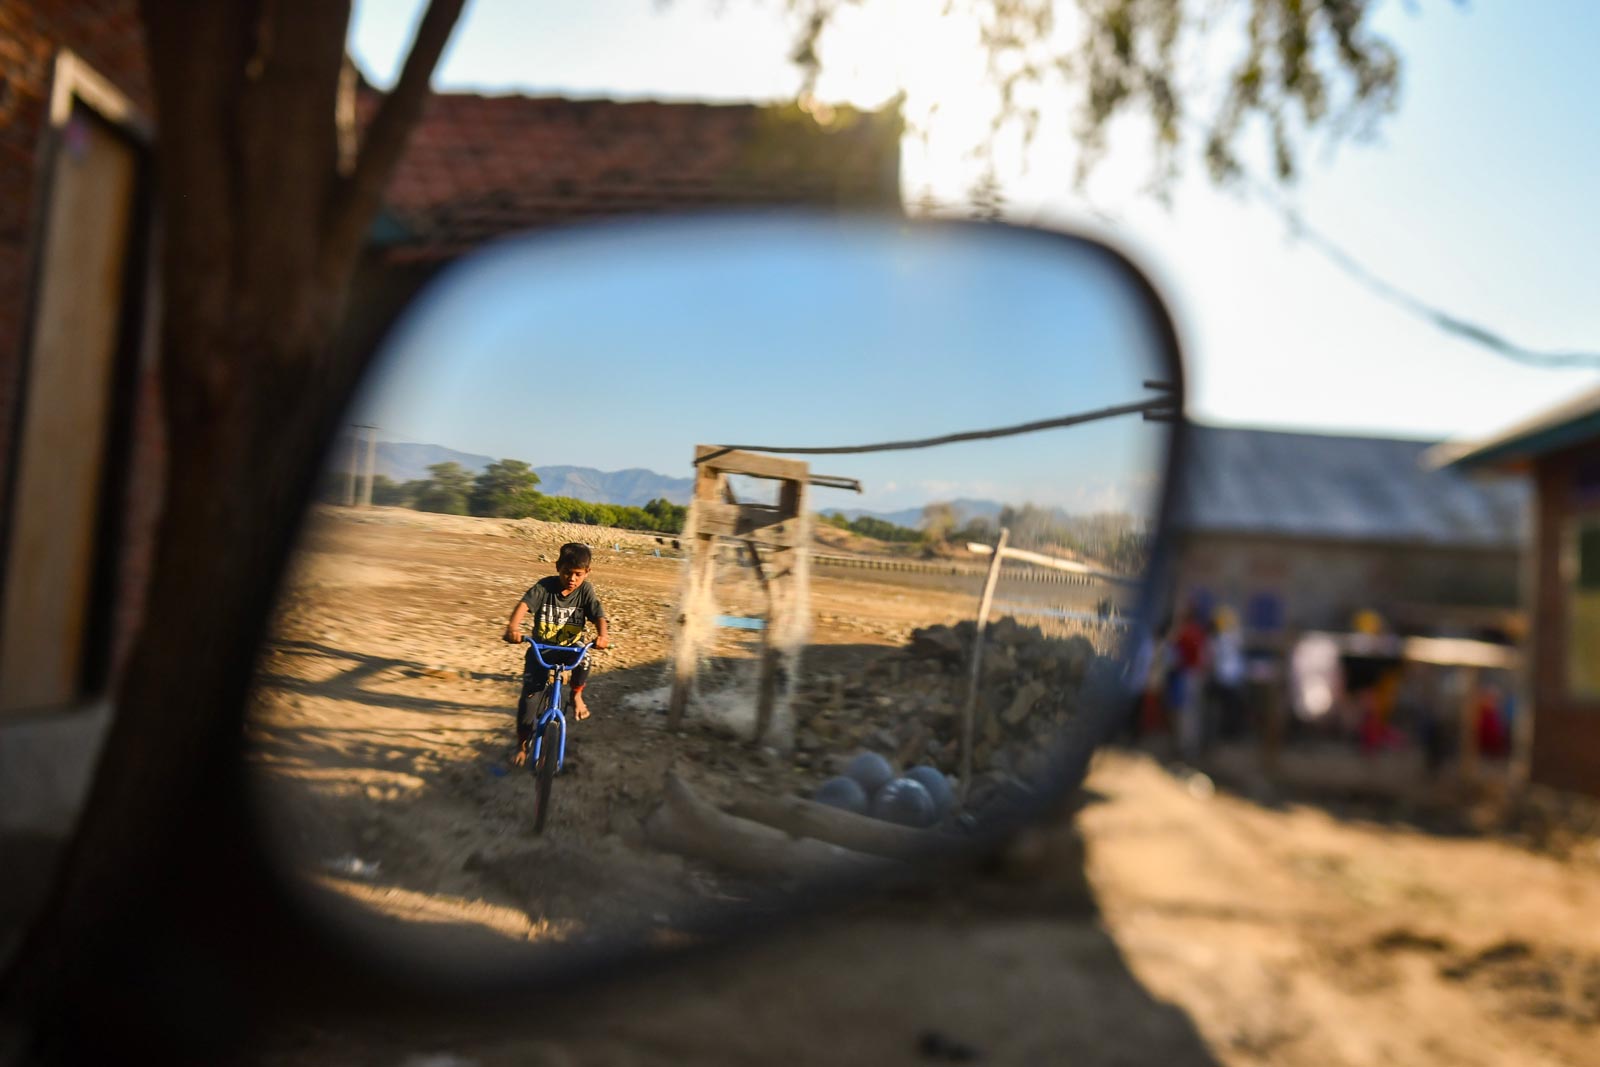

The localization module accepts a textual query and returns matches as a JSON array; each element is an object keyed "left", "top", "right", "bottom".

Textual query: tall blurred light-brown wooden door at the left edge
[{"left": 0, "top": 101, "right": 139, "bottom": 713}]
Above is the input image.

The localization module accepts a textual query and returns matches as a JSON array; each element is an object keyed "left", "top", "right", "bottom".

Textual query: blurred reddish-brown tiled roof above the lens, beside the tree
[{"left": 358, "top": 90, "right": 902, "bottom": 259}]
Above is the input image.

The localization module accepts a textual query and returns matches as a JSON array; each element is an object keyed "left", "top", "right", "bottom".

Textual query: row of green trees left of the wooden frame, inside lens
[{"left": 334, "top": 459, "right": 688, "bottom": 533}]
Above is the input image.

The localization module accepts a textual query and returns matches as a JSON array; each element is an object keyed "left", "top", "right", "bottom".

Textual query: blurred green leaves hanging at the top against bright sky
[{"left": 789, "top": 0, "right": 1400, "bottom": 195}]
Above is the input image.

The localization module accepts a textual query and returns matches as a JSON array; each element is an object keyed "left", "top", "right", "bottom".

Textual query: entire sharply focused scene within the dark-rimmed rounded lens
[{"left": 246, "top": 218, "right": 1174, "bottom": 973}]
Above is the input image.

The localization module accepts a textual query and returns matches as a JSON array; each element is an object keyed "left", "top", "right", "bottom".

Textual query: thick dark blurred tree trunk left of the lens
[{"left": 0, "top": 0, "right": 462, "bottom": 1061}]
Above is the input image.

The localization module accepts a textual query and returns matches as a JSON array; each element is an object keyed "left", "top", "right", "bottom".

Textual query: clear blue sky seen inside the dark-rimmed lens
[{"left": 358, "top": 219, "right": 1165, "bottom": 512}]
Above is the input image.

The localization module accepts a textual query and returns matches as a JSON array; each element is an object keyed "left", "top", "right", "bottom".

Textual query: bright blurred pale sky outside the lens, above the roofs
[{"left": 352, "top": 0, "right": 1600, "bottom": 502}]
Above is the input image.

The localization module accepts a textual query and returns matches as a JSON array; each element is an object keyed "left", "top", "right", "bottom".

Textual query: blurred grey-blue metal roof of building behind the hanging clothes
[{"left": 1176, "top": 426, "right": 1531, "bottom": 549}]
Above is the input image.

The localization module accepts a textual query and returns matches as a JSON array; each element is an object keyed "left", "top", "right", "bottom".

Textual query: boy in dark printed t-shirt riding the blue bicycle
[{"left": 501, "top": 542, "right": 610, "bottom": 765}]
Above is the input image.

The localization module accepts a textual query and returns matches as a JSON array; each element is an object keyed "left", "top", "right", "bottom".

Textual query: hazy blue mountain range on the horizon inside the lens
[{"left": 352, "top": 438, "right": 1002, "bottom": 528}]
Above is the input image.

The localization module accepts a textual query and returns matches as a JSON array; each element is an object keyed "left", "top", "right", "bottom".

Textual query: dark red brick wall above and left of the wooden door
[{"left": 0, "top": 0, "right": 150, "bottom": 470}]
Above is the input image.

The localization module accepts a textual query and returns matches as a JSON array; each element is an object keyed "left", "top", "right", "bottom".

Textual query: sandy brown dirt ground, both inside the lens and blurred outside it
[{"left": 251, "top": 510, "right": 1600, "bottom": 1067}]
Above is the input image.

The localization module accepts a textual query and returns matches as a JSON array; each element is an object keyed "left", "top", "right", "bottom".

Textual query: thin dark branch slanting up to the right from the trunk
[{"left": 322, "top": 0, "right": 466, "bottom": 280}]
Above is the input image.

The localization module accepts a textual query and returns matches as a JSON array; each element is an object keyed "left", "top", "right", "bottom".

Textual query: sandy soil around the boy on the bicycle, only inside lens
[{"left": 250, "top": 509, "right": 971, "bottom": 966}]
